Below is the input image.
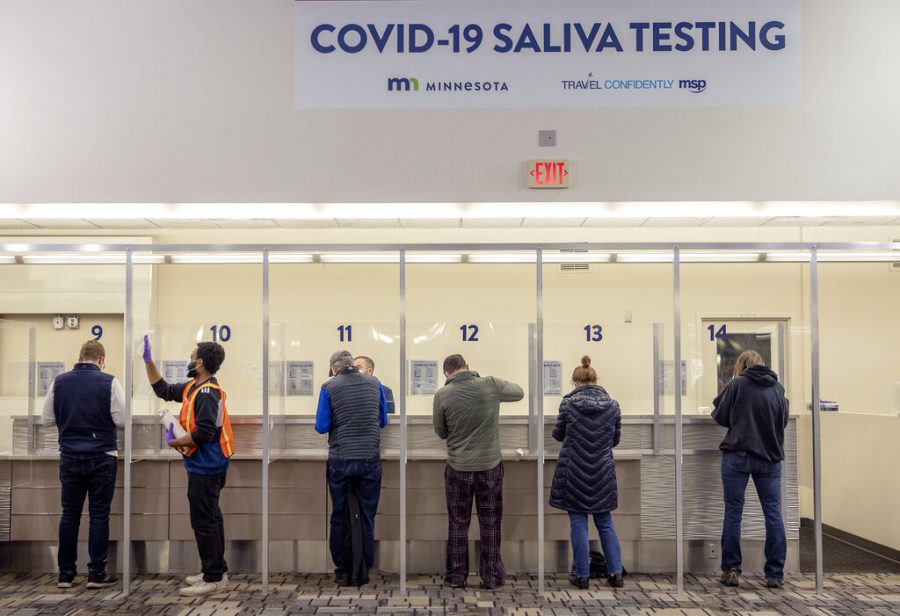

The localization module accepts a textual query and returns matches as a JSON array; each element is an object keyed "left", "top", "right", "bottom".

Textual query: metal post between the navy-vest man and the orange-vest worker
[{"left": 121, "top": 248, "right": 134, "bottom": 596}]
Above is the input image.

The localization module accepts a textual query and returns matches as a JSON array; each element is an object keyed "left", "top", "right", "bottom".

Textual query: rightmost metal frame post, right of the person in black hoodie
[{"left": 809, "top": 246, "right": 825, "bottom": 595}]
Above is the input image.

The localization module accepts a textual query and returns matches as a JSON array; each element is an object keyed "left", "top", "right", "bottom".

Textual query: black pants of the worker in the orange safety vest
[{"left": 188, "top": 471, "right": 228, "bottom": 582}]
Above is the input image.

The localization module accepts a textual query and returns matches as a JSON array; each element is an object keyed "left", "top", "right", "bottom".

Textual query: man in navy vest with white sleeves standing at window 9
[{"left": 41, "top": 340, "right": 125, "bottom": 588}]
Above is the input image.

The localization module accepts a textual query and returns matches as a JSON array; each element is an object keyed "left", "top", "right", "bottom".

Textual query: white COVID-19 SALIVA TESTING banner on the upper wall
[{"left": 294, "top": 0, "right": 802, "bottom": 109}]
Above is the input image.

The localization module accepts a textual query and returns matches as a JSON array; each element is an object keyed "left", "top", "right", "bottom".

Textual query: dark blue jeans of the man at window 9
[{"left": 57, "top": 453, "right": 118, "bottom": 577}]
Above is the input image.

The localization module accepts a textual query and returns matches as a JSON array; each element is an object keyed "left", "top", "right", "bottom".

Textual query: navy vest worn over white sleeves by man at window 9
[{"left": 53, "top": 364, "right": 116, "bottom": 453}]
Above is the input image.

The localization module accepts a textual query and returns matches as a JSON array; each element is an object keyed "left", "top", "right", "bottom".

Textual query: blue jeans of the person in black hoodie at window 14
[{"left": 722, "top": 452, "right": 787, "bottom": 579}]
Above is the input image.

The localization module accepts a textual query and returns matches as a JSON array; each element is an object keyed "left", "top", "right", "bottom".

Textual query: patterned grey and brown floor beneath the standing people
[{"left": 0, "top": 573, "right": 900, "bottom": 616}]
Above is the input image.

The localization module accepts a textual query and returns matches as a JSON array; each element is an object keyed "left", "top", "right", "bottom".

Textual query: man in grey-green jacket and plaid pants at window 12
[{"left": 433, "top": 355, "right": 525, "bottom": 589}]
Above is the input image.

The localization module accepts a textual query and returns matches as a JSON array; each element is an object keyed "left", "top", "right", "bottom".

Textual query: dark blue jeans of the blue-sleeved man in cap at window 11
[{"left": 326, "top": 458, "right": 381, "bottom": 577}]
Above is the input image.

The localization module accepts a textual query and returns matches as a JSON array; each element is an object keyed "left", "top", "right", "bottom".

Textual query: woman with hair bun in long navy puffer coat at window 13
[{"left": 550, "top": 355, "right": 623, "bottom": 588}]
